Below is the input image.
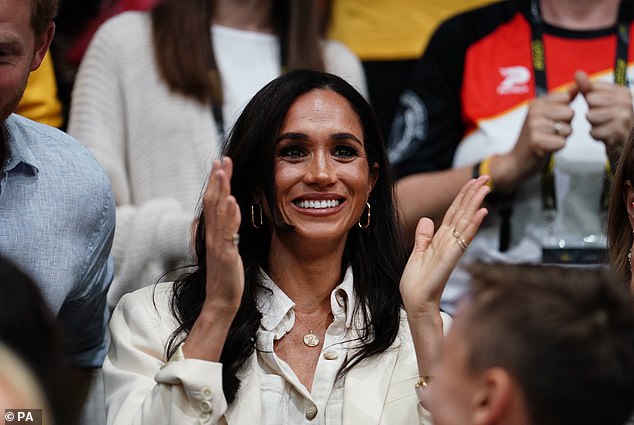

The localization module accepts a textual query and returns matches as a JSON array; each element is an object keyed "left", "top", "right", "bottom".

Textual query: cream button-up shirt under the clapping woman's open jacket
[{"left": 256, "top": 268, "right": 355, "bottom": 425}]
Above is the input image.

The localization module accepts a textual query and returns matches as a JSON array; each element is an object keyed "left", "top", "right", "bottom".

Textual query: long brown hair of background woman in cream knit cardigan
[{"left": 151, "top": 0, "right": 324, "bottom": 105}]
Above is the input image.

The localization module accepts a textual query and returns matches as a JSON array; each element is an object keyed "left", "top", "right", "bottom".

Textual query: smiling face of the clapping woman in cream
[{"left": 275, "top": 89, "right": 377, "bottom": 247}]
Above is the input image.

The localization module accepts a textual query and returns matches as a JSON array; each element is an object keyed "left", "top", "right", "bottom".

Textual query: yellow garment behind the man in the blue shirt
[{"left": 15, "top": 52, "right": 63, "bottom": 128}]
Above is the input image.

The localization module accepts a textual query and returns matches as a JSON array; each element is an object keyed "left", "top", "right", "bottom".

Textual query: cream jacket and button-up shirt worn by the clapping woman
[{"left": 103, "top": 270, "right": 440, "bottom": 425}]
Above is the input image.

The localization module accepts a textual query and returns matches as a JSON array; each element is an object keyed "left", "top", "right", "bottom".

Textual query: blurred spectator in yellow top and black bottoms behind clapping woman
[{"left": 324, "top": 0, "right": 493, "bottom": 138}]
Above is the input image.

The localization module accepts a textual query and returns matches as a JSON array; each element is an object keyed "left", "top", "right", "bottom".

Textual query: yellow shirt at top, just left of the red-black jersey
[{"left": 328, "top": 0, "right": 493, "bottom": 60}]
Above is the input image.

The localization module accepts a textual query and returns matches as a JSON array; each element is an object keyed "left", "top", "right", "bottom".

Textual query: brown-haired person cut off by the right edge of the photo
[{"left": 608, "top": 127, "right": 634, "bottom": 292}]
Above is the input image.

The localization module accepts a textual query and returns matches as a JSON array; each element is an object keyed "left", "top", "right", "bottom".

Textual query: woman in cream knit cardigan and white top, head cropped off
[{"left": 68, "top": 0, "right": 365, "bottom": 307}]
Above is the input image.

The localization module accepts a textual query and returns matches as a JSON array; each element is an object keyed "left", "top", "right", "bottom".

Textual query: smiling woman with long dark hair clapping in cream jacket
[{"left": 104, "top": 70, "right": 489, "bottom": 425}]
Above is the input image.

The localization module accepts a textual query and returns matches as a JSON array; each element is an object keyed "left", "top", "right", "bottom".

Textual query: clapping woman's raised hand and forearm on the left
[{"left": 183, "top": 157, "right": 244, "bottom": 361}]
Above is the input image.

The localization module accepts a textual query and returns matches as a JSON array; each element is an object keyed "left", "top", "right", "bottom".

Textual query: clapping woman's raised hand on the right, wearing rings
[{"left": 400, "top": 176, "right": 490, "bottom": 320}]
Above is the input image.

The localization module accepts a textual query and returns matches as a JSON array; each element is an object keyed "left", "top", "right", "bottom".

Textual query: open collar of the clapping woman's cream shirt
[{"left": 257, "top": 266, "right": 356, "bottom": 337}]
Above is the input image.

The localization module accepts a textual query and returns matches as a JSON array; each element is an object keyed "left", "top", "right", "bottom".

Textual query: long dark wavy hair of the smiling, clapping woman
[{"left": 166, "top": 70, "right": 406, "bottom": 403}]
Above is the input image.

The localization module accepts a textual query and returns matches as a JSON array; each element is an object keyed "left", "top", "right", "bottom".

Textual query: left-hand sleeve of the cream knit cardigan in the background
[{"left": 68, "top": 12, "right": 194, "bottom": 306}]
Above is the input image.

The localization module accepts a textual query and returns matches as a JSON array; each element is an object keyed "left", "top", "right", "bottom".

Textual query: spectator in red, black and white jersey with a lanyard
[{"left": 388, "top": 0, "right": 634, "bottom": 312}]
